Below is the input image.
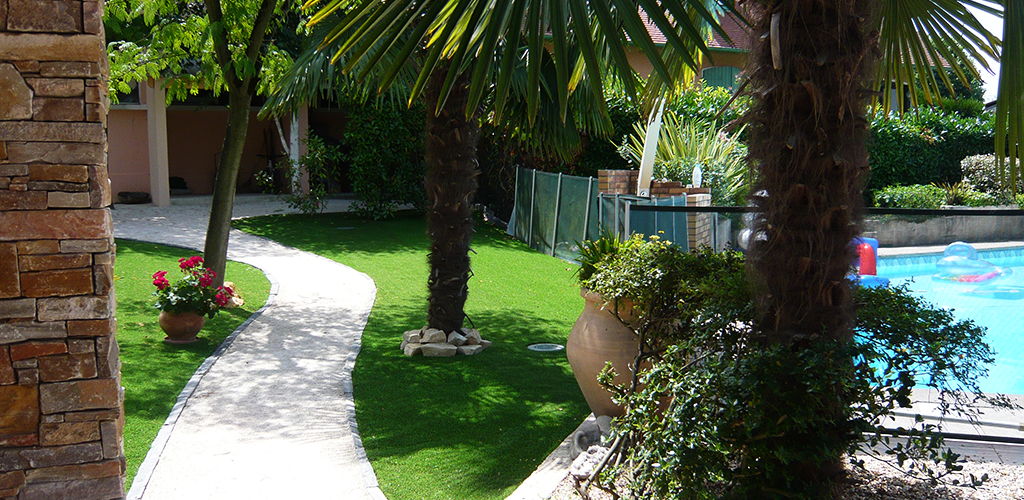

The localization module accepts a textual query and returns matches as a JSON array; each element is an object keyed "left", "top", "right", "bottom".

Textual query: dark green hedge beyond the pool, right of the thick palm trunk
[{"left": 867, "top": 108, "right": 993, "bottom": 193}]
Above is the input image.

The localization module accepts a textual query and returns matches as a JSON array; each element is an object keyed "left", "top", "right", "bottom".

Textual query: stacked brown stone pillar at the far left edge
[{"left": 0, "top": 0, "right": 125, "bottom": 500}]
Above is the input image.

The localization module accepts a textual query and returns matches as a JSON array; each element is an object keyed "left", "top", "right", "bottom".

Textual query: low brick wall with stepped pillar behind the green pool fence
[{"left": 597, "top": 170, "right": 713, "bottom": 250}]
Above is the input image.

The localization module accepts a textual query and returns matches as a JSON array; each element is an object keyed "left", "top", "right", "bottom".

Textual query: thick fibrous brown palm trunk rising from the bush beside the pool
[{"left": 748, "top": 0, "right": 874, "bottom": 495}]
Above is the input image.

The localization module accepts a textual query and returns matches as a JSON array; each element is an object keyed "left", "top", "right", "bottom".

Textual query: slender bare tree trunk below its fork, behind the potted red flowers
[{"left": 203, "top": 89, "right": 252, "bottom": 286}]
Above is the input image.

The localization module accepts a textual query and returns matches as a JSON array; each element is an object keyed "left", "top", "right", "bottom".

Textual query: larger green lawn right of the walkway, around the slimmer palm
[{"left": 233, "top": 213, "right": 590, "bottom": 500}]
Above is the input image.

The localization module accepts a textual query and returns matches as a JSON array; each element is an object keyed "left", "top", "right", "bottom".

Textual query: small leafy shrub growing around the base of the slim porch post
[{"left": 256, "top": 132, "right": 342, "bottom": 214}]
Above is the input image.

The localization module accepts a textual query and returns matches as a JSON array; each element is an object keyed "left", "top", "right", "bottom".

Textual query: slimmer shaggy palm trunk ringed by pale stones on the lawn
[{"left": 424, "top": 65, "right": 480, "bottom": 332}]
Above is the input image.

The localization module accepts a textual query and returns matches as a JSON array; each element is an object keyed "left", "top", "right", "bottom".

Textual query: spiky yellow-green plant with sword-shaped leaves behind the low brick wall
[{"left": 620, "top": 111, "right": 751, "bottom": 205}]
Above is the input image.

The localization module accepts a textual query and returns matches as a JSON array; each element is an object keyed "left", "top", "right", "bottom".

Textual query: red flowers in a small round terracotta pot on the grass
[{"left": 153, "top": 255, "right": 233, "bottom": 344}]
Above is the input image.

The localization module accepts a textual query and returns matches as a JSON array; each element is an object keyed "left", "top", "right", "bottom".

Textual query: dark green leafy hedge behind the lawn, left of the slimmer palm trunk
[{"left": 344, "top": 101, "right": 426, "bottom": 219}]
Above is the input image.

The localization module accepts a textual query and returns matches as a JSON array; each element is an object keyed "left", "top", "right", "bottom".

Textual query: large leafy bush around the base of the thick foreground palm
[{"left": 584, "top": 237, "right": 1014, "bottom": 499}]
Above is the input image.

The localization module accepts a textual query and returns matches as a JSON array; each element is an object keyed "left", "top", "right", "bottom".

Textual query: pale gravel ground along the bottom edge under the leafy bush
[{"left": 550, "top": 459, "right": 1024, "bottom": 500}]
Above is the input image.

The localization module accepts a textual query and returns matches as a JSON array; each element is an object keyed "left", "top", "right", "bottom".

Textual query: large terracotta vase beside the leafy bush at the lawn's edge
[{"left": 565, "top": 290, "right": 639, "bottom": 417}]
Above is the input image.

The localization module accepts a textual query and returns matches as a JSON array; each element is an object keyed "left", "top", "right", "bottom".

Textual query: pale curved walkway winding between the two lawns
[{"left": 113, "top": 196, "right": 384, "bottom": 500}]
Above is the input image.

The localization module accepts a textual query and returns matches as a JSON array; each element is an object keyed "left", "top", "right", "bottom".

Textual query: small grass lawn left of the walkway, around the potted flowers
[{"left": 114, "top": 240, "right": 270, "bottom": 487}]
